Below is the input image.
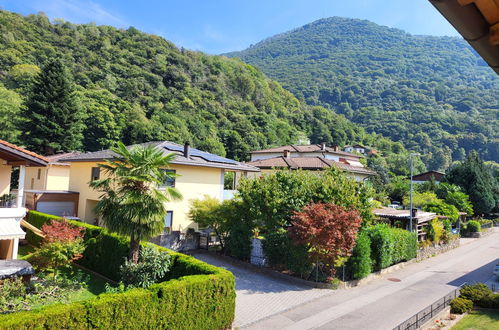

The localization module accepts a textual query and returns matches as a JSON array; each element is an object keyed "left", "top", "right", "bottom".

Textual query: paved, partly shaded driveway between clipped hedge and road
[{"left": 193, "top": 253, "right": 334, "bottom": 328}]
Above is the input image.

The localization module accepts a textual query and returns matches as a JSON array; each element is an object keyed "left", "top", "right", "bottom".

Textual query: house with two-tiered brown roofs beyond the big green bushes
[{"left": 247, "top": 143, "right": 375, "bottom": 181}]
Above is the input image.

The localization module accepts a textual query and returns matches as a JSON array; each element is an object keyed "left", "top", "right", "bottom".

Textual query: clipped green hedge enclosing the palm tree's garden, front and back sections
[{"left": 5, "top": 211, "right": 236, "bottom": 329}]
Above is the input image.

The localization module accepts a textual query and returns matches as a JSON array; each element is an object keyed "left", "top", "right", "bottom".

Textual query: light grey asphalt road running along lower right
[{"left": 247, "top": 228, "right": 499, "bottom": 330}]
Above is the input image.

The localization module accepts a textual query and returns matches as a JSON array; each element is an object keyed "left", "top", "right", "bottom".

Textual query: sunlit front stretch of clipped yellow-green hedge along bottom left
[{"left": 0, "top": 272, "right": 235, "bottom": 329}]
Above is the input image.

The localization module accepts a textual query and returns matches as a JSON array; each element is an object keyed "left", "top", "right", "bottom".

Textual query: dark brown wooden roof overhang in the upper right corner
[{"left": 429, "top": 0, "right": 499, "bottom": 74}]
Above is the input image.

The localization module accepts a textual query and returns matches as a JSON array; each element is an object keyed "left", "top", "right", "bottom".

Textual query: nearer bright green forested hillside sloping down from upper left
[{"left": 0, "top": 11, "right": 405, "bottom": 159}]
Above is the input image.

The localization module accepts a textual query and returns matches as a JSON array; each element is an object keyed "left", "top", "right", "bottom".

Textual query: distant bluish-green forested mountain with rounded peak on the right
[{"left": 226, "top": 17, "right": 499, "bottom": 169}]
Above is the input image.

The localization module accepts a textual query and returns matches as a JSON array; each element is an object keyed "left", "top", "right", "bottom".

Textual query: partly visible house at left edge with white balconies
[{"left": 0, "top": 140, "right": 48, "bottom": 259}]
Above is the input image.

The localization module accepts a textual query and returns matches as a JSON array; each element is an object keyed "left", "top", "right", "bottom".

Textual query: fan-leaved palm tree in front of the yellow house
[{"left": 90, "top": 142, "right": 182, "bottom": 263}]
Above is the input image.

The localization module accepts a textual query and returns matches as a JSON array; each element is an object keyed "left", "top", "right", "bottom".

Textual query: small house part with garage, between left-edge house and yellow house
[{"left": 24, "top": 152, "right": 78, "bottom": 217}]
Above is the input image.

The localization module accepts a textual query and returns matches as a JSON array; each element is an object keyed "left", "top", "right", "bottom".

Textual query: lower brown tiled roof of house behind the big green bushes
[{"left": 247, "top": 156, "right": 375, "bottom": 175}]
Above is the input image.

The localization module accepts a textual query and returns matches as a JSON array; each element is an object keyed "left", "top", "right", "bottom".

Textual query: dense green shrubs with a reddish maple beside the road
[{"left": 190, "top": 169, "right": 418, "bottom": 283}]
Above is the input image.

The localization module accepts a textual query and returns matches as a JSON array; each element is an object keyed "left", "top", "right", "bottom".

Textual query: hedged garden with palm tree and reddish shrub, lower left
[{"left": 0, "top": 144, "right": 235, "bottom": 329}]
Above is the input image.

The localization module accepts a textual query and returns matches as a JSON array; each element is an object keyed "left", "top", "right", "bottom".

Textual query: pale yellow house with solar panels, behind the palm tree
[{"left": 63, "top": 141, "right": 259, "bottom": 232}]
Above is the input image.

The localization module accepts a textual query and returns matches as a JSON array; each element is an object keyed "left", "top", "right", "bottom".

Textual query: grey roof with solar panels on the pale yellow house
[{"left": 60, "top": 141, "right": 260, "bottom": 172}]
